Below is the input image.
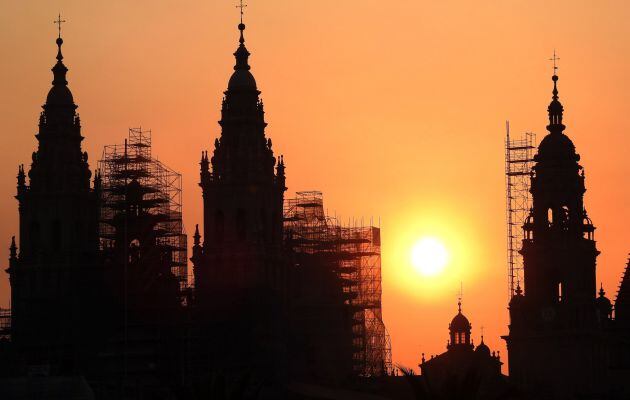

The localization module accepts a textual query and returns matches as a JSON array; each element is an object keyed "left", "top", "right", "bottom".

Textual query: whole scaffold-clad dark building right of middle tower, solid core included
[{"left": 284, "top": 192, "right": 391, "bottom": 380}]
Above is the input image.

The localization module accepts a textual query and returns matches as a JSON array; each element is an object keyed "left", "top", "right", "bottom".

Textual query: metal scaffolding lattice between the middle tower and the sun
[{"left": 284, "top": 191, "right": 392, "bottom": 376}]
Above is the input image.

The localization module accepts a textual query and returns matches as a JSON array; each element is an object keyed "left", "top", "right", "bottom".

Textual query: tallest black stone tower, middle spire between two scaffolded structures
[{"left": 191, "top": 22, "right": 288, "bottom": 376}]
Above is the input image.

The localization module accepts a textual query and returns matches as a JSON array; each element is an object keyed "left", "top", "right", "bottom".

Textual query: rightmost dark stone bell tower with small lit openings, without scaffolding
[{"left": 505, "top": 74, "right": 608, "bottom": 399}]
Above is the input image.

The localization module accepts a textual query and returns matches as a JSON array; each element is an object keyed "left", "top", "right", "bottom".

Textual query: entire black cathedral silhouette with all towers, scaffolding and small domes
[{"left": 0, "top": 10, "right": 630, "bottom": 400}]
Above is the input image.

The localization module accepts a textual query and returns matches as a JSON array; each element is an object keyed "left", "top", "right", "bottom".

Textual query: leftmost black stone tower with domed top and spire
[{"left": 7, "top": 32, "right": 100, "bottom": 373}]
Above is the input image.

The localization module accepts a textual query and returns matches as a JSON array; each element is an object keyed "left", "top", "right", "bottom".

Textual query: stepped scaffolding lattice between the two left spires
[{"left": 99, "top": 128, "right": 188, "bottom": 295}]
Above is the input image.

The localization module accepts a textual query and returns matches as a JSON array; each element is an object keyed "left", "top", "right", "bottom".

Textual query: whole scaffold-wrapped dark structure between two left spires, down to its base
[{"left": 95, "top": 129, "right": 190, "bottom": 397}]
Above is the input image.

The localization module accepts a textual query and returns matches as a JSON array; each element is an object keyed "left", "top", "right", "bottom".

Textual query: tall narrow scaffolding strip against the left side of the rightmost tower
[{"left": 505, "top": 122, "right": 536, "bottom": 299}]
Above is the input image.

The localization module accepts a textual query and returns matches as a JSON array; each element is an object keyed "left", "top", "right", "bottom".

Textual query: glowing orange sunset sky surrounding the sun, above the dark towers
[{"left": 0, "top": 0, "right": 630, "bottom": 374}]
